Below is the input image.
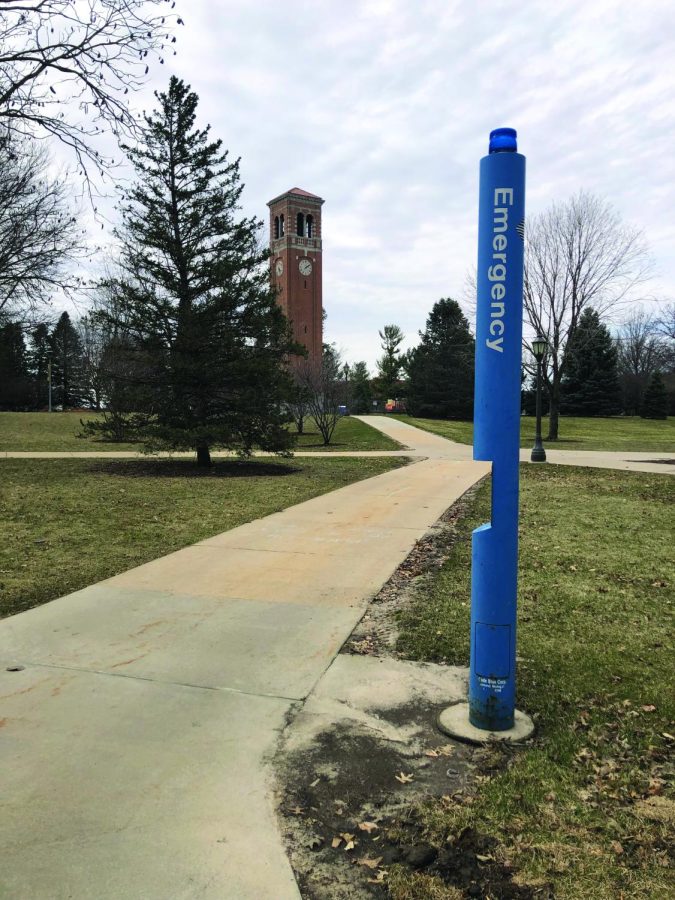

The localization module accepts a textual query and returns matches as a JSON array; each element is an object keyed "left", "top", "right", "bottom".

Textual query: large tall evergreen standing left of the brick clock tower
[{"left": 99, "top": 77, "right": 299, "bottom": 465}]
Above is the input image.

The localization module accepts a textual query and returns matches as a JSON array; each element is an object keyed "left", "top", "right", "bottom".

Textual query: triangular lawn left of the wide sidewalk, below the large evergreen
[{"left": 0, "top": 458, "right": 405, "bottom": 616}]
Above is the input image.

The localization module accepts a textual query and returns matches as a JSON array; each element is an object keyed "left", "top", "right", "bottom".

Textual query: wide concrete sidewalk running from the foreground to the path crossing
[{"left": 0, "top": 446, "right": 489, "bottom": 900}]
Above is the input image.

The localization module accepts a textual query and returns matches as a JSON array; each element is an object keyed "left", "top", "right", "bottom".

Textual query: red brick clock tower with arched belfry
[{"left": 267, "top": 188, "right": 323, "bottom": 362}]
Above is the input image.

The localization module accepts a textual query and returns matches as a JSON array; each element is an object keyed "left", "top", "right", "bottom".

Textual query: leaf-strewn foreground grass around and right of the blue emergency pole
[{"left": 390, "top": 466, "right": 675, "bottom": 900}]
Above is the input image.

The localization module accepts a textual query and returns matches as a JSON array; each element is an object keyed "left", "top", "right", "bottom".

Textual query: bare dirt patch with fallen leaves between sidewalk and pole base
[{"left": 278, "top": 704, "right": 553, "bottom": 900}]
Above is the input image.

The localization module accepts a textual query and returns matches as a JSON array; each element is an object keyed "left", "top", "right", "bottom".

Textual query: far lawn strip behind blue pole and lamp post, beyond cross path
[{"left": 400, "top": 416, "right": 675, "bottom": 453}]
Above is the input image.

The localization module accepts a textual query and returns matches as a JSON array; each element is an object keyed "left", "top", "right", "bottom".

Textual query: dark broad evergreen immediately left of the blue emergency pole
[{"left": 408, "top": 297, "right": 475, "bottom": 419}]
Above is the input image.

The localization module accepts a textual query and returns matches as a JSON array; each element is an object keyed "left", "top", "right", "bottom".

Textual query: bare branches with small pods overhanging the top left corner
[{"left": 0, "top": 0, "right": 182, "bottom": 176}]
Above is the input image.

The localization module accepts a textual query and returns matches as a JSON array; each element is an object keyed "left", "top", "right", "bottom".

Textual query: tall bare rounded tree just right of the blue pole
[{"left": 524, "top": 191, "right": 650, "bottom": 440}]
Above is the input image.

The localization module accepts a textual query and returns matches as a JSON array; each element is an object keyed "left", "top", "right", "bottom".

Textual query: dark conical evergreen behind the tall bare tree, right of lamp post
[{"left": 560, "top": 307, "right": 621, "bottom": 416}]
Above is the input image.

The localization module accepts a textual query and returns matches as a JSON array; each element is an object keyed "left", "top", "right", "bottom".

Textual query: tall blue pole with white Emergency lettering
[{"left": 469, "top": 128, "right": 525, "bottom": 731}]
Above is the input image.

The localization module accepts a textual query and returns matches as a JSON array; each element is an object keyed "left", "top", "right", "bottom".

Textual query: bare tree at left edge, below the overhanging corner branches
[{"left": 0, "top": 134, "right": 85, "bottom": 317}]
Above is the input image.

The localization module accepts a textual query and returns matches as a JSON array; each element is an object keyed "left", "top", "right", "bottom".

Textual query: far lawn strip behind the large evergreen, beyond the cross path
[{"left": 0, "top": 411, "right": 400, "bottom": 453}]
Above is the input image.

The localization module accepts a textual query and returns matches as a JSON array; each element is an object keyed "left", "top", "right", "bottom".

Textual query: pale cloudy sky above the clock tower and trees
[{"left": 66, "top": 0, "right": 675, "bottom": 367}]
